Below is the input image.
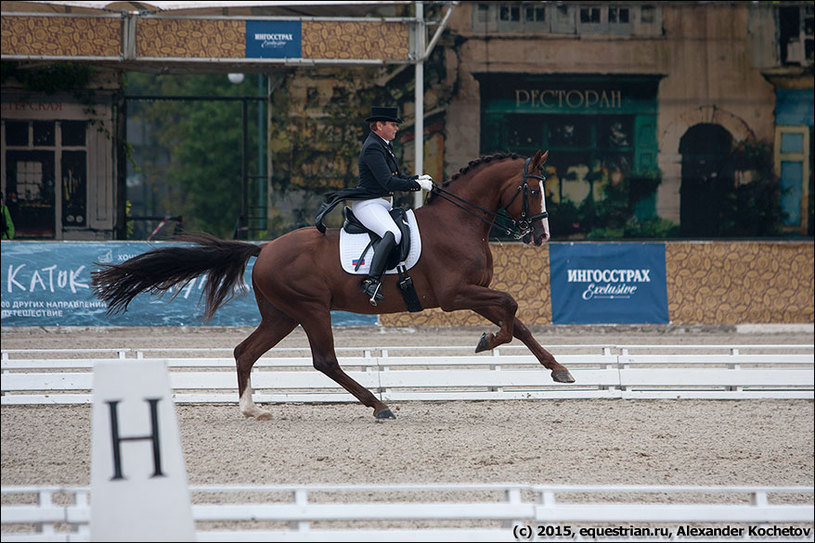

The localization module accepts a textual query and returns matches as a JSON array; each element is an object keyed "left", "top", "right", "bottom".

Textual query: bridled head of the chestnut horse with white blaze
[{"left": 501, "top": 151, "right": 550, "bottom": 246}]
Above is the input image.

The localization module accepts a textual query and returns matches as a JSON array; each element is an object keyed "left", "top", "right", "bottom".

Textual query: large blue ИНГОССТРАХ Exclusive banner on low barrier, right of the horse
[{"left": 549, "top": 243, "right": 668, "bottom": 324}]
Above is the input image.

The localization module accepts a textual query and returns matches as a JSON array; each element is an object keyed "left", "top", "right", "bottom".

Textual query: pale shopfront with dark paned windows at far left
[{"left": 1, "top": 72, "right": 124, "bottom": 240}]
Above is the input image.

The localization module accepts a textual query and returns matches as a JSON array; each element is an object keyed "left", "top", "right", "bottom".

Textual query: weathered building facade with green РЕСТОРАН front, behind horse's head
[{"left": 428, "top": 2, "right": 813, "bottom": 237}]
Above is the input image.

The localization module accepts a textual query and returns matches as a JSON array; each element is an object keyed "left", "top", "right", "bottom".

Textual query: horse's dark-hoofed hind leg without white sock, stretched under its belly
[{"left": 301, "top": 307, "right": 396, "bottom": 419}]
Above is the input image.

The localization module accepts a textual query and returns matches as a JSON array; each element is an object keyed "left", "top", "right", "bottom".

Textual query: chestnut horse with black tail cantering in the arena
[{"left": 91, "top": 150, "right": 574, "bottom": 420}]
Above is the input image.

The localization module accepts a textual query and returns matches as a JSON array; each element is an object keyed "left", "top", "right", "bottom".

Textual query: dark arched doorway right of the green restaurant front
[{"left": 679, "top": 124, "right": 733, "bottom": 237}]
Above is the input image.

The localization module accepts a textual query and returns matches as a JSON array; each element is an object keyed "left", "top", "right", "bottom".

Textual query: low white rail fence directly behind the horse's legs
[{"left": 1, "top": 345, "right": 815, "bottom": 405}]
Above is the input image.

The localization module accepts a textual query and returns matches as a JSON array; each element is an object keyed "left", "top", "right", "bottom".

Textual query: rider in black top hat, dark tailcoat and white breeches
[{"left": 352, "top": 106, "right": 433, "bottom": 305}]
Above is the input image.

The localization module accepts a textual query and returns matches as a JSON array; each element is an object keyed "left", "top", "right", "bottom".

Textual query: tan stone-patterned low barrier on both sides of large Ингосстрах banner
[{"left": 381, "top": 241, "right": 815, "bottom": 326}]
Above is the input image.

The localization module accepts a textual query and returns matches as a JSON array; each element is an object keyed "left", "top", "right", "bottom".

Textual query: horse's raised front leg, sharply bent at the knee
[{"left": 440, "top": 285, "right": 518, "bottom": 353}]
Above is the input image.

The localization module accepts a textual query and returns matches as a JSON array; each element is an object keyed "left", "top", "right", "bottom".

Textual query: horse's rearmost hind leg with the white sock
[{"left": 234, "top": 295, "right": 297, "bottom": 420}]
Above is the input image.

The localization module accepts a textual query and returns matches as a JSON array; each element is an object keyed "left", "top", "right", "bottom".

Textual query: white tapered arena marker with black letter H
[{"left": 90, "top": 360, "right": 195, "bottom": 541}]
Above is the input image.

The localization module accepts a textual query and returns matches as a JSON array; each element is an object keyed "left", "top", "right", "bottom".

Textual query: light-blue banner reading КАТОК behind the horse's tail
[{"left": 0, "top": 241, "right": 376, "bottom": 326}]
